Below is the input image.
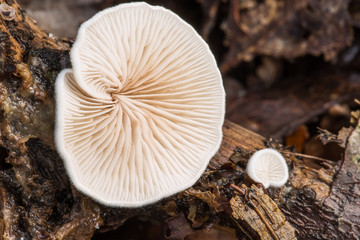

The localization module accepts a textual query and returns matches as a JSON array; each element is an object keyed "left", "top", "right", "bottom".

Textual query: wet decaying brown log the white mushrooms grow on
[{"left": 0, "top": 0, "right": 360, "bottom": 239}]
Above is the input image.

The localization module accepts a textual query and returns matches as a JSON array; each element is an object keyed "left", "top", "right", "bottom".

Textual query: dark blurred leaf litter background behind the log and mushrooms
[{"left": 19, "top": 0, "right": 360, "bottom": 239}]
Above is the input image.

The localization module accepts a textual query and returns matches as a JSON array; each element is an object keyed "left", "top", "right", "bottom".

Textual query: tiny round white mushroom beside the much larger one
[{"left": 246, "top": 149, "right": 289, "bottom": 188}]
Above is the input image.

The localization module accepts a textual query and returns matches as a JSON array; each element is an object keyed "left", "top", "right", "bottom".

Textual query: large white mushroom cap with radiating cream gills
[{"left": 56, "top": 3, "right": 225, "bottom": 207}]
